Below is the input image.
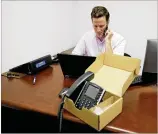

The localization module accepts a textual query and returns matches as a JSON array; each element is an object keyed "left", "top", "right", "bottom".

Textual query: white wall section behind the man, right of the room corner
[{"left": 75, "top": 1, "right": 157, "bottom": 71}]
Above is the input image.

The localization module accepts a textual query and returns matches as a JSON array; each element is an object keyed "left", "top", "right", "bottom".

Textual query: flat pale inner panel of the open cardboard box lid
[{"left": 91, "top": 65, "right": 132, "bottom": 97}]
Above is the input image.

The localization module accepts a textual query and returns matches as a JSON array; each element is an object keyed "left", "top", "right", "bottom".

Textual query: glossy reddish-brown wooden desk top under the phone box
[{"left": 1, "top": 65, "right": 157, "bottom": 133}]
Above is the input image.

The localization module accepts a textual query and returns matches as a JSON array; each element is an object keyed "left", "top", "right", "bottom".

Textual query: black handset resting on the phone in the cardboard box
[{"left": 66, "top": 71, "right": 94, "bottom": 97}]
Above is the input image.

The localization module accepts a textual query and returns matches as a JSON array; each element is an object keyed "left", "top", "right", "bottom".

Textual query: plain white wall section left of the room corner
[{"left": 2, "top": 1, "right": 74, "bottom": 72}]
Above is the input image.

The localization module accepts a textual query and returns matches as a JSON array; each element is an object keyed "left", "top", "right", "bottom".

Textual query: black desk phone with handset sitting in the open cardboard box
[{"left": 66, "top": 71, "right": 105, "bottom": 109}]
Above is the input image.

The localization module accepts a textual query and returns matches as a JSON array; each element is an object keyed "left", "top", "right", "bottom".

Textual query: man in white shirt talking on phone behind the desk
[{"left": 72, "top": 6, "right": 126, "bottom": 56}]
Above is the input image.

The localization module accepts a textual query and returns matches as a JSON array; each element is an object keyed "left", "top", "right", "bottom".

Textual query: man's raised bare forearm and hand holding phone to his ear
[{"left": 105, "top": 30, "right": 113, "bottom": 54}]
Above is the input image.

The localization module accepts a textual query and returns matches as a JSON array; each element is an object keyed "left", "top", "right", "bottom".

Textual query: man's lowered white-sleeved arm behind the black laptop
[{"left": 72, "top": 36, "right": 86, "bottom": 55}]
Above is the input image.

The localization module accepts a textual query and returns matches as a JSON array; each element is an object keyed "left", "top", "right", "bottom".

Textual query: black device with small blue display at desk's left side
[{"left": 9, "top": 55, "right": 52, "bottom": 74}]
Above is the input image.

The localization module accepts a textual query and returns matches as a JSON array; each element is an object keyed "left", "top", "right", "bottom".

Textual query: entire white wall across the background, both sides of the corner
[{"left": 2, "top": 1, "right": 157, "bottom": 72}]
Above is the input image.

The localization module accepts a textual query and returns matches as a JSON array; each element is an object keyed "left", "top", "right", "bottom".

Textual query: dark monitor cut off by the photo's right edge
[{"left": 142, "top": 39, "right": 158, "bottom": 83}]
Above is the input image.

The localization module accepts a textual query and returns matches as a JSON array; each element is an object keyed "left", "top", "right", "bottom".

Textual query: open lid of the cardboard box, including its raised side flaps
[{"left": 86, "top": 53, "right": 140, "bottom": 97}]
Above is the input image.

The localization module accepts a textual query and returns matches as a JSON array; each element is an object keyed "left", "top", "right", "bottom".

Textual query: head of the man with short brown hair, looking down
[{"left": 91, "top": 6, "right": 110, "bottom": 39}]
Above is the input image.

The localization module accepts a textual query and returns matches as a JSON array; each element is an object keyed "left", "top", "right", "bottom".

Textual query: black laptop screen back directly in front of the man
[{"left": 57, "top": 53, "right": 96, "bottom": 78}]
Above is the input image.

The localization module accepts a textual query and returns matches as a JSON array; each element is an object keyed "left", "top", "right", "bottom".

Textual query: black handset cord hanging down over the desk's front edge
[{"left": 58, "top": 95, "right": 65, "bottom": 133}]
